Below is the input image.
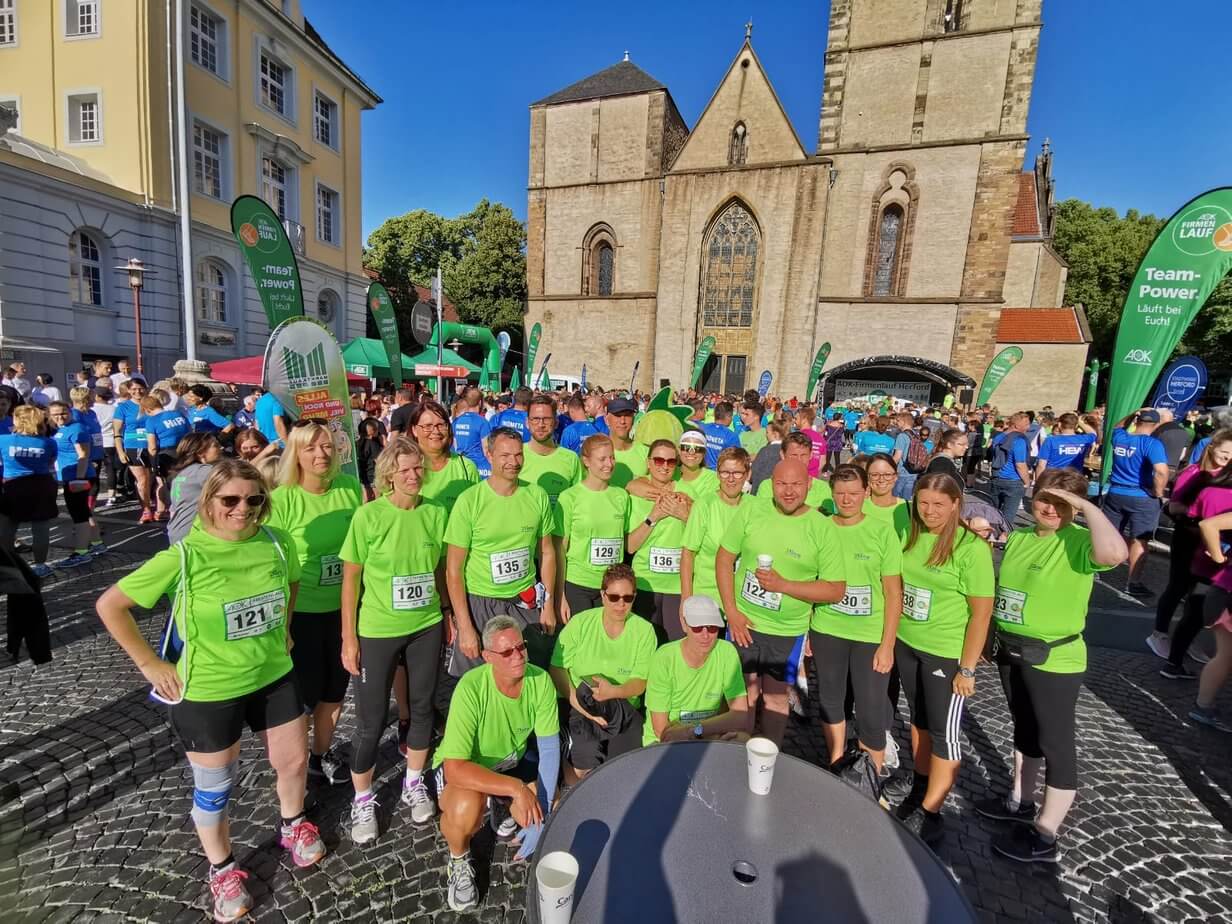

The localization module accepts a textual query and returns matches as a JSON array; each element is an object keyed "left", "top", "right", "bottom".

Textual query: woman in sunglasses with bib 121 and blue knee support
[{"left": 97, "top": 460, "right": 325, "bottom": 920}]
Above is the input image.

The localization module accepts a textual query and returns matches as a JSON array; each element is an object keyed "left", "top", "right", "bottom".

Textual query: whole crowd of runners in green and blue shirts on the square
[{"left": 0, "top": 357, "right": 1232, "bottom": 920}]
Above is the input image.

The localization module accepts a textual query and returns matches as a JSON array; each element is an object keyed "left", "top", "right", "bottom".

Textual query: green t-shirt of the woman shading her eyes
[{"left": 993, "top": 524, "right": 1111, "bottom": 674}]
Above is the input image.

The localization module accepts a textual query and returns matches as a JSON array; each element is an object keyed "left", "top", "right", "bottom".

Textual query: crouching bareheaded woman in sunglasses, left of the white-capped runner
[{"left": 549, "top": 564, "right": 658, "bottom": 785}]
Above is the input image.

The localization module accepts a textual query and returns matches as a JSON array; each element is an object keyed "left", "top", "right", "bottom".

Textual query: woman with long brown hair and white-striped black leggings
[{"left": 894, "top": 474, "right": 994, "bottom": 843}]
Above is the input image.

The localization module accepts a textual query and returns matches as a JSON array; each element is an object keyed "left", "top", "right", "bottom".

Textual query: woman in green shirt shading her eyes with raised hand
[{"left": 976, "top": 468, "right": 1129, "bottom": 862}]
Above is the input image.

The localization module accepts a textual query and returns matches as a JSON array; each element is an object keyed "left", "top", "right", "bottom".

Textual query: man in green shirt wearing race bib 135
[{"left": 445, "top": 426, "right": 556, "bottom": 676}]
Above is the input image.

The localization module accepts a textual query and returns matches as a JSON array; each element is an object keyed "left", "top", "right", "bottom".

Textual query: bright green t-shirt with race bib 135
[{"left": 445, "top": 482, "right": 554, "bottom": 599}]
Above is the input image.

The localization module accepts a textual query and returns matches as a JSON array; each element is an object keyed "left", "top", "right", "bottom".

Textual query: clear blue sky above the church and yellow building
[{"left": 303, "top": 0, "right": 1232, "bottom": 235}]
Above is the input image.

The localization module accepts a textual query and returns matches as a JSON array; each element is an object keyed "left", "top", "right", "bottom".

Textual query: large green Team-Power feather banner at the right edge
[{"left": 1100, "top": 186, "right": 1232, "bottom": 482}]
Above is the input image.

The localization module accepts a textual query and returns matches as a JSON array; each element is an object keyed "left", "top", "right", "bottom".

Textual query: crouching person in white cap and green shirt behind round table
[{"left": 642, "top": 595, "right": 753, "bottom": 745}]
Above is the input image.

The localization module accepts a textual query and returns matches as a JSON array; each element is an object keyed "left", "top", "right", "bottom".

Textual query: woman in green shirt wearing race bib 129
[{"left": 557, "top": 434, "right": 628, "bottom": 622}]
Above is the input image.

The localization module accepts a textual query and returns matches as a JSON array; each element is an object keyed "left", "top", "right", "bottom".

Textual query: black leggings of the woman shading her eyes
[{"left": 998, "top": 664, "right": 1083, "bottom": 790}]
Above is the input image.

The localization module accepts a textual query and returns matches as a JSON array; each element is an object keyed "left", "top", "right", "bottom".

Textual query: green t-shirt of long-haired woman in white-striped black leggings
[{"left": 898, "top": 529, "right": 995, "bottom": 659}]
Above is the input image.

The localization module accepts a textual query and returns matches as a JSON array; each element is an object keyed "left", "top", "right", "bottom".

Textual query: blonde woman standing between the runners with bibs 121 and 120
[{"left": 270, "top": 420, "right": 363, "bottom": 786}]
